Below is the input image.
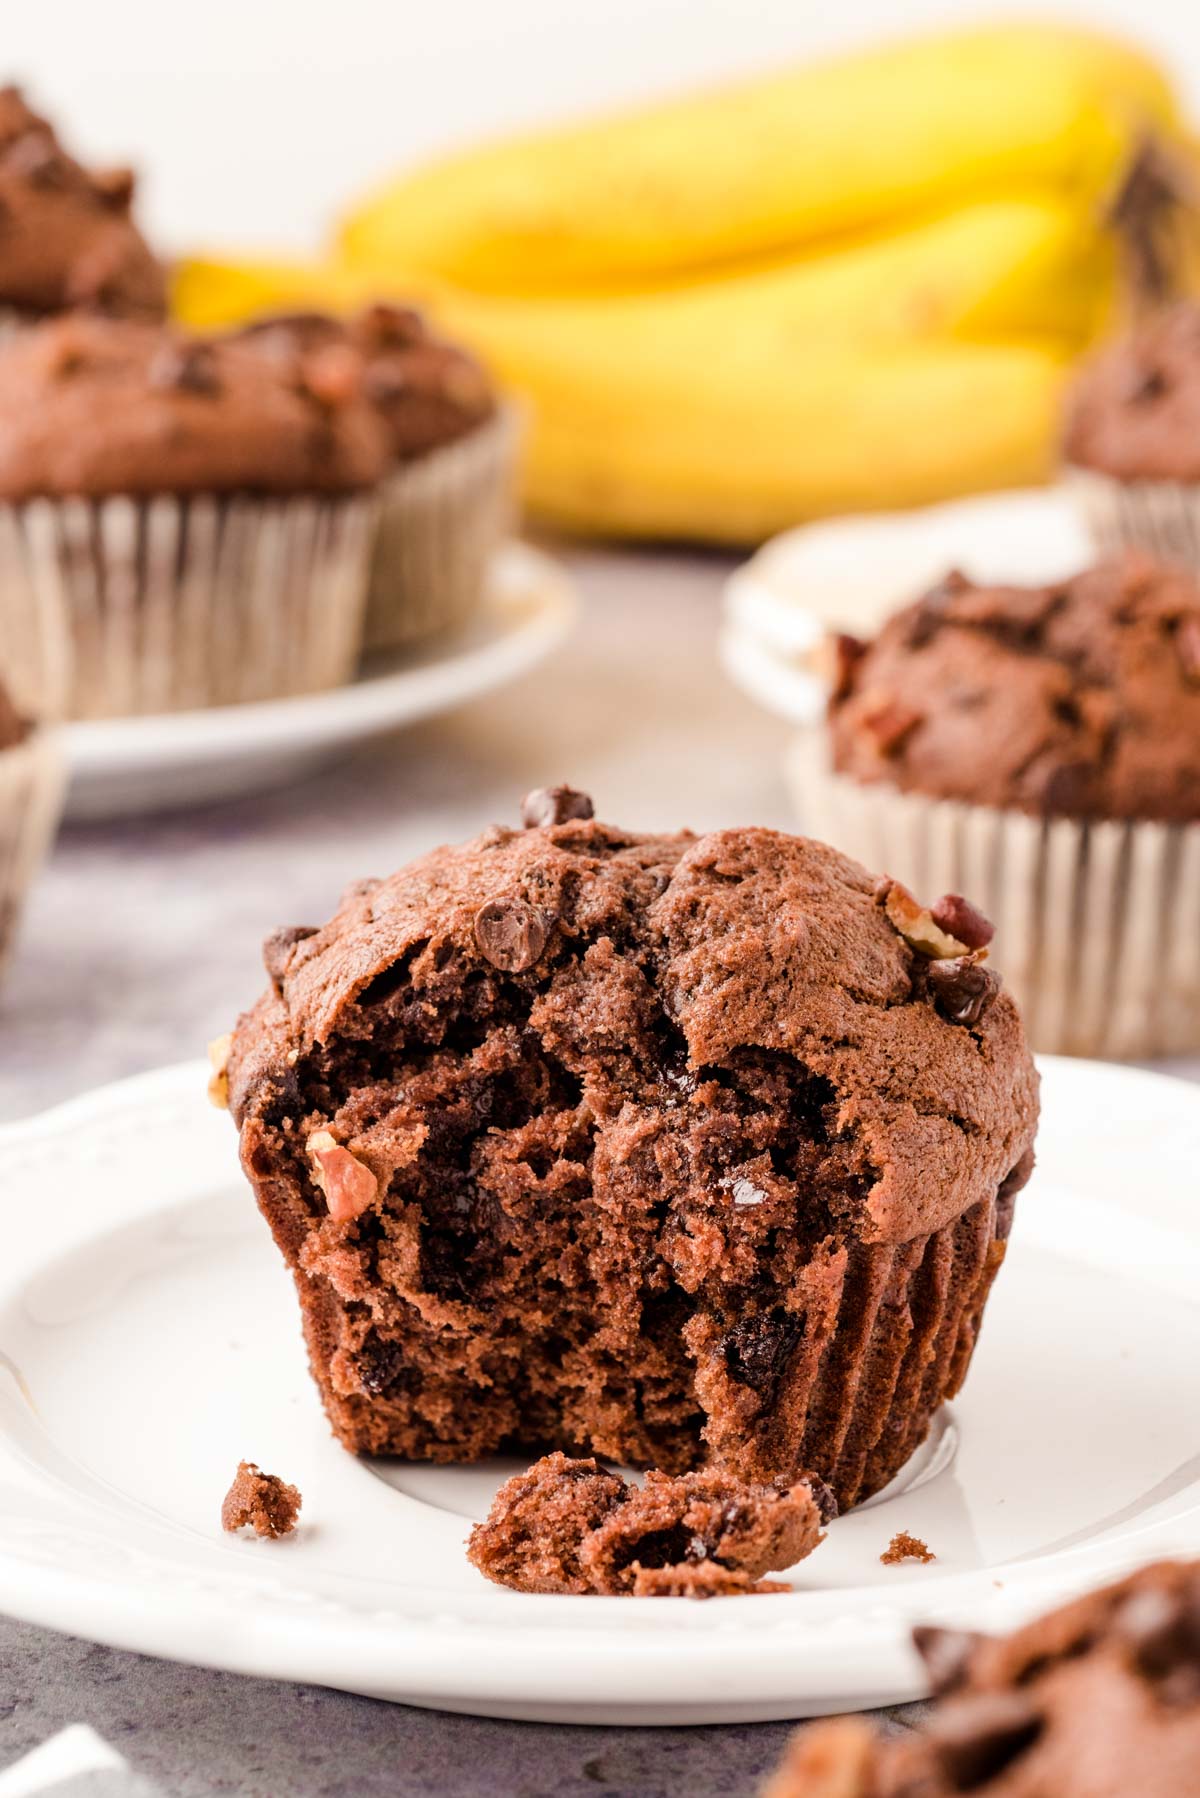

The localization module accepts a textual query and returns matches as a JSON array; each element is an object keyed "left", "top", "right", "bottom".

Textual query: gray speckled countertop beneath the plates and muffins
[{"left": 0, "top": 554, "right": 1194, "bottom": 1798}]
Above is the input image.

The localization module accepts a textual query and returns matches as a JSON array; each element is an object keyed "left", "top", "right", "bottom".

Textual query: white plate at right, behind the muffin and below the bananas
[{"left": 721, "top": 487, "right": 1090, "bottom": 725}]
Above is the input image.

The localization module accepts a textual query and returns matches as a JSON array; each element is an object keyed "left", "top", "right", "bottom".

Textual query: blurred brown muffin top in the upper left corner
[{"left": 0, "top": 88, "right": 166, "bottom": 318}]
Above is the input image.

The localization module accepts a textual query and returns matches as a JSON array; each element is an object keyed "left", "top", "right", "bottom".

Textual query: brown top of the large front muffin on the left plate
[{"left": 0, "top": 315, "right": 389, "bottom": 500}]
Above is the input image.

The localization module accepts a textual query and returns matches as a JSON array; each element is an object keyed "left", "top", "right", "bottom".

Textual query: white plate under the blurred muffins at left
[{"left": 65, "top": 543, "right": 576, "bottom": 818}]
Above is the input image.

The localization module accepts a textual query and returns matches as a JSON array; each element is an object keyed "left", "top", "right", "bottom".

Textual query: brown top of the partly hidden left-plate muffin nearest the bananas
[{"left": 241, "top": 306, "right": 497, "bottom": 462}]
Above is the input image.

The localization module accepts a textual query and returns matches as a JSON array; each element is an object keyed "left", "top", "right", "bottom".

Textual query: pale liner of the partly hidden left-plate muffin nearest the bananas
[{"left": 367, "top": 406, "right": 520, "bottom": 649}]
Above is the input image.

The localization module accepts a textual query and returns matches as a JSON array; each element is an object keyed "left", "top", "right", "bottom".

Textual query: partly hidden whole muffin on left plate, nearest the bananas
[{"left": 245, "top": 306, "right": 516, "bottom": 649}]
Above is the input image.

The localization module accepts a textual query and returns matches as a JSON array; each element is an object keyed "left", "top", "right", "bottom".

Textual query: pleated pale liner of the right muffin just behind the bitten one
[{"left": 788, "top": 728, "right": 1200, "bottom": 1059}]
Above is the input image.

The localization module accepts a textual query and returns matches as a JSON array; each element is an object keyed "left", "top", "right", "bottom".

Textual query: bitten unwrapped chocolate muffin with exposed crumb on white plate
[{"left": 216, "top": 788, "right": 1036, "bottom": 1505}]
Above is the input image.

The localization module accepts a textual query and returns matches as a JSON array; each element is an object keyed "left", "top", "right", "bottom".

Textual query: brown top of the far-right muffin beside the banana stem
[{"left": 1063, "top": 300, "right": 1200, "bottom": 480}]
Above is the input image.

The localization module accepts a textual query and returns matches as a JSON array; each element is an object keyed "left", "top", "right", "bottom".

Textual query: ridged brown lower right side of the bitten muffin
[{"left": 687, "top": 1199, "right": 1004, "bottom": 1509}]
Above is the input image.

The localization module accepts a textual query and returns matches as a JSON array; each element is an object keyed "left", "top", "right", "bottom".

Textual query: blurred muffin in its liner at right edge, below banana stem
[{"left": 1063, "top": 300, "right": 1200, "bottom": 568}]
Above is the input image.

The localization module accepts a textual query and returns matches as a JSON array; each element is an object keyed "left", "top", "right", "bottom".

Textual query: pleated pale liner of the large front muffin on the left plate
[{"left": 0, "top": 494, "right": 374, "bottom": 717}]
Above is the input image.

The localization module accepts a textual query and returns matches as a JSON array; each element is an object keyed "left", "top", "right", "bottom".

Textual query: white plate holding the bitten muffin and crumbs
[{"left": 0, "top": 1061, "right": 1200, "bottom": 1722}]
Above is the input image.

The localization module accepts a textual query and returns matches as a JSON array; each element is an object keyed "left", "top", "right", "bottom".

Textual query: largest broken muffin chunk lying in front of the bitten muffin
[{"left": 466, "top": 1453, "right": 835, "bottom": 1598}]
